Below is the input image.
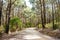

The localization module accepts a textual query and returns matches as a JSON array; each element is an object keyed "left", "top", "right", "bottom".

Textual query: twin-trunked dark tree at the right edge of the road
[{"left": 39, "top": 0, "right": 46, "bottom": 29}]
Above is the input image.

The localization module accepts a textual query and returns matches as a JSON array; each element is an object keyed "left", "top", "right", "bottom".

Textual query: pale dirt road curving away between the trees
[{"left": 2, "top": 28, "right": 57, "bottom": 40}]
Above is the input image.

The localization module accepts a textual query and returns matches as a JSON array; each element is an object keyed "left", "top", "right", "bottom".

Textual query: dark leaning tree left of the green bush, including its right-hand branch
[{"left": 5, "top": 0, "right": 16, "bottom": 34}]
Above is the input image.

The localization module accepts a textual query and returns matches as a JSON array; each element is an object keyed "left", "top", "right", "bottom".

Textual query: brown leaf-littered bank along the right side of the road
[{"left": 39, "top": 29, "right": 60, "bottom": 38}]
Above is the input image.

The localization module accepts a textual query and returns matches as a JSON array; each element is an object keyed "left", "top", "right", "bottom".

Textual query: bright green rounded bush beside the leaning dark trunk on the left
[{"left": 10, "top": 17, "right": 23, "bottom": 30}]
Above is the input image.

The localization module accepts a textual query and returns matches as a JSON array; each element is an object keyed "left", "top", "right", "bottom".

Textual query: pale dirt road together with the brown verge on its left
[{"left": 0, "top": 28, "right": 59, "bottom": 40}]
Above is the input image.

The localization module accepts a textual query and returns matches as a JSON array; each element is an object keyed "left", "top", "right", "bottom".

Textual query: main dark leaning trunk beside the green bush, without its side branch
[{"left": 5, "top": 0, "right": 11, "bottom": 34}]
